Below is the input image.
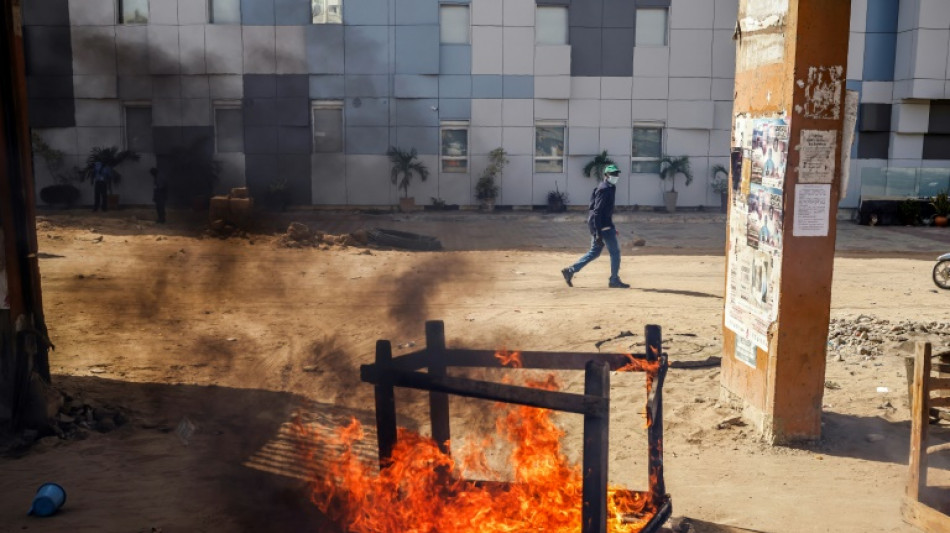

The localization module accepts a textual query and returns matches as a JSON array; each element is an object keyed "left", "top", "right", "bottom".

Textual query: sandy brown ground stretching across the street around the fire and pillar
[{"left": 0, "top": 210, "right": 950, "bottom": 533}]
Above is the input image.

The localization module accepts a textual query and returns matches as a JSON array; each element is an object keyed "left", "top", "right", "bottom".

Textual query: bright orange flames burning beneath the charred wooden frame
[{"left": 297, "top": 352, "right": 662, "bottom": 533}]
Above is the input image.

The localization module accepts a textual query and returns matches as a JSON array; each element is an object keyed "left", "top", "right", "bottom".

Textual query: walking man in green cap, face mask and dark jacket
[{"left": 561, "top": 165, "right": 630, "bottom": 289}]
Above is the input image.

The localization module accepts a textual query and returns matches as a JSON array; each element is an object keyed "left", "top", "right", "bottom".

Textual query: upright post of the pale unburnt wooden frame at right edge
[{"left": 906, "top": 341, "right": 931, "bottom": 501}]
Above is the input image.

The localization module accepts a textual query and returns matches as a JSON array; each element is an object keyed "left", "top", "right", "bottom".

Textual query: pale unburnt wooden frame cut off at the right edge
[{"left": 901, "top": 342, "right": 950, "bottom": 533}]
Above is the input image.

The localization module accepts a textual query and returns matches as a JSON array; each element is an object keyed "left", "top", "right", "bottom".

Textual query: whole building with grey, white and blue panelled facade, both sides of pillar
[{"left": 23, "top": 0, "right": 950, "bottom": 211}]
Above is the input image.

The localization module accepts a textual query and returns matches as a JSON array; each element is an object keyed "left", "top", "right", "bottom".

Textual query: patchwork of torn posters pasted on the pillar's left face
[{"left": 725, "top": 116, "right": 789, "bottom": 352}]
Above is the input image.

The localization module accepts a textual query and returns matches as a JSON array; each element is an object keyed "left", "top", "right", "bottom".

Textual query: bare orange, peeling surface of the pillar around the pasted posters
[{"left": 722, "top": 0, "right": 850, "bottom": 443}]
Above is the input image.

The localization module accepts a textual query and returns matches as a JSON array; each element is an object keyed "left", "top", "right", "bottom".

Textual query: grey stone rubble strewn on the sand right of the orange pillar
[{"left": 828, "top": 315, "right": 950, "bottom": 361}]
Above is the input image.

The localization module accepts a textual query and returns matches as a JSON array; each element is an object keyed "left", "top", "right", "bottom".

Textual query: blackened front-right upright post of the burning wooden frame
[{"left": 581, "top": 361, "right": 610, "bottom": 533}]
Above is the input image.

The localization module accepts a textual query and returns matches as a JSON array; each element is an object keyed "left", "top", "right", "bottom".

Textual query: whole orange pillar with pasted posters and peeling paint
[{"left": 722, "top": 0, "right": 851, "bottom": 444}]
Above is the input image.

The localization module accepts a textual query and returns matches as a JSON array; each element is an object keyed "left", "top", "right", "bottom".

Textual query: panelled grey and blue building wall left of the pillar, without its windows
[{"left": 24, "top": 0, "right": 738, "bottom": 206}]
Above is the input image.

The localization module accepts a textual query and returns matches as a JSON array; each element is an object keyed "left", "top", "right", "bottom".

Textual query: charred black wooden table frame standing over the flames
[{"left": 360, "top": 321, "right": 672, "bottom": 533}]
